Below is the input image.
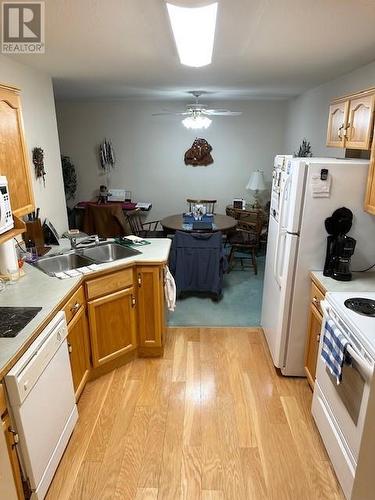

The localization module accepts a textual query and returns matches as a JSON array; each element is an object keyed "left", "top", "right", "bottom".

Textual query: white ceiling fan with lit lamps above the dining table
[{"left": 153, "top": 90, "right": 242, "bottom": 129}]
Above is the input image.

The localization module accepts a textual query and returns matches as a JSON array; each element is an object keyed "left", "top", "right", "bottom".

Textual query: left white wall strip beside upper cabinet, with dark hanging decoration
[{"left": 0, "top": 55, "right": 68, "bottom": 233}]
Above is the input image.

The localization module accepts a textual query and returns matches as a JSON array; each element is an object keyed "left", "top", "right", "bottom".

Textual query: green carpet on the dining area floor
[{"left": 168, "top": 256, "right": 265, "bottom": 326}]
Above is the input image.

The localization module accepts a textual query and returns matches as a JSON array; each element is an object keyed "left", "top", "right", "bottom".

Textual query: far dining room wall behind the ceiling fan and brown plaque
[{"left": 57, "top": 101, "right": 286, "bottom": 218}]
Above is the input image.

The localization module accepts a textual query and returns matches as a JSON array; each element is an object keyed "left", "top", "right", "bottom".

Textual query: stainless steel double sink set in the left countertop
[{"left": 34, "top": 243, "right": 141, "bottom": 276}]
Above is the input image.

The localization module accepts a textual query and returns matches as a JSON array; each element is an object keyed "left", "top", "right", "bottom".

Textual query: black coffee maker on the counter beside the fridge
[{"left": 323, "top": 207, "right": 357, "bottom": 281}]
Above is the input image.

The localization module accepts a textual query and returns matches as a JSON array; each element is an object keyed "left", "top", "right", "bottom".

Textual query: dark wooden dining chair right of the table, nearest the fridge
[{"left": 228, "top": 211, "right": 263, "bottom": 274}]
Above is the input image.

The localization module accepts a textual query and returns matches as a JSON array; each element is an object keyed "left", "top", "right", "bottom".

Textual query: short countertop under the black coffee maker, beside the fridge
[{"left": 311, "top": 271, "right": 375, "bottom": 292}]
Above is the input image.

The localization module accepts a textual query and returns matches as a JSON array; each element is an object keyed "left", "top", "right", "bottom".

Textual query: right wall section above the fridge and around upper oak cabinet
[{"left": 285, "top": 62, "right": 375, "bottom": 157}]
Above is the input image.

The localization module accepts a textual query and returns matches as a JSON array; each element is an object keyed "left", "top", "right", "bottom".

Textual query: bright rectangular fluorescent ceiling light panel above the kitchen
[{"left": 167, "top": 2, "right": 217, "bottom": 68}]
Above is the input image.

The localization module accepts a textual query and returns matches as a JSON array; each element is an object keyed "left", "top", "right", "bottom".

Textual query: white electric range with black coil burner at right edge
[{"left": 312, "top": 292, "right": 375, "bottom": 500}]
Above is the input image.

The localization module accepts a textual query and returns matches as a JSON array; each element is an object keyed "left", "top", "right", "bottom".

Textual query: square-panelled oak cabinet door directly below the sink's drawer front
[{"left": 88, "top": 287, "right": 137, "bottom": 367}]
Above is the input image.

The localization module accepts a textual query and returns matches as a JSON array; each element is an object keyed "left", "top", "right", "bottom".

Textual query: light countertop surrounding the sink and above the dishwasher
[{"left": 0, "top": 238, "right": 171, "bottom": 380}]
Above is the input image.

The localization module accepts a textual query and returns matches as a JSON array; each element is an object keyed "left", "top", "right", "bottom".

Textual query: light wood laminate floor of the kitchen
[{"left": 47, "top": 328, "right": 343, "bottom": 500}]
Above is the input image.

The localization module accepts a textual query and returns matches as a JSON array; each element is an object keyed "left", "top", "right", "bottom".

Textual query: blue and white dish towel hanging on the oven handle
[{"left": 321, "top": 319, "right": 349, "bottom": 385}]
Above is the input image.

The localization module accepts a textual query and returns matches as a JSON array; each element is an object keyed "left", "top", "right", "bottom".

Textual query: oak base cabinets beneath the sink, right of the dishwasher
[{"left": 64, "top": 264, "right": 165, "bottom": 394}]
